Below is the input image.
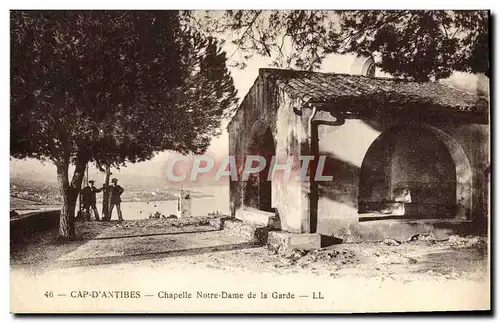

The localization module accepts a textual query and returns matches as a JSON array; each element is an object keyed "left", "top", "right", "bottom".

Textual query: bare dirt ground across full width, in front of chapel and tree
[{"left": 11, "top": 218, "right": 488, "bottom": 280}]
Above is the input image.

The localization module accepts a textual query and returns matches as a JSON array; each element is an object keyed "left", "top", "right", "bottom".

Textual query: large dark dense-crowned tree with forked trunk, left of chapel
[{"left": 11, "top": 11, "right": 236, "bottom": 238}]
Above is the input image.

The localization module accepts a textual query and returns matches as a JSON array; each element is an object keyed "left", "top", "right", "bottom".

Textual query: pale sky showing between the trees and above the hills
[{"left": 10, "top": 15, "right": 488, "bottom": 186}]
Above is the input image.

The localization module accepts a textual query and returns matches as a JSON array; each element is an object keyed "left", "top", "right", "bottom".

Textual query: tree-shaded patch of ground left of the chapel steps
[{"left": 11, "top": 220, "right": 261, "bottom": 271}]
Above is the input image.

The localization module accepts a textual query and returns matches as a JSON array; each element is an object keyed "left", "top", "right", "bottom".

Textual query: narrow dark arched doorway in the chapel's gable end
[{"left": 243, "top": 124, "right": 276, "bottom": 212}]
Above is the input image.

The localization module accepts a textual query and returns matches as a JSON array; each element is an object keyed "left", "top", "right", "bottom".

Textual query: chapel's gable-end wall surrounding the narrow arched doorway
[{"left": 228, "top": 75, "right": 309, "bottom": 233}]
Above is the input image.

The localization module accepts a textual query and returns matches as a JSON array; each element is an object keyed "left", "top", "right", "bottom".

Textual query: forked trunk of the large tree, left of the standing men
[{"left": 56, "top": 157, "right": 87, "bottom": 240}]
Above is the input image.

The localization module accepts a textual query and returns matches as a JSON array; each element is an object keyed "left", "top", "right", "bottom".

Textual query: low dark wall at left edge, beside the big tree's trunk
[{"left": 10, "top": 210, "right": 61, "bottom": 244}]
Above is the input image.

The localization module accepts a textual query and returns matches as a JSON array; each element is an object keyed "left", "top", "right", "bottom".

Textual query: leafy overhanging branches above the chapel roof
[{"left": 193, "top": 10, "right": 489, "bottom": 81}]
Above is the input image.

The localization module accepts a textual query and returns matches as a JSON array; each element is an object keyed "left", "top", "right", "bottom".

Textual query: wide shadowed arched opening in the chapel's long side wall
[{"left": 358, "top": 125, "right": 472, "bottom": 218}]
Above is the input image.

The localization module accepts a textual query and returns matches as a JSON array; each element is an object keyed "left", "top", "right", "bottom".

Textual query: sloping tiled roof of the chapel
[{"left": 260, "top": 69, "right": 488, "bottom": 112}]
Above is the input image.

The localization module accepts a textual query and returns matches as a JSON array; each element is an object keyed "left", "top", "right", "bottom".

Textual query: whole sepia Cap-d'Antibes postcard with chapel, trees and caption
[{"left": 10, "top": 10, "right": 491, "bottom": 314}]
